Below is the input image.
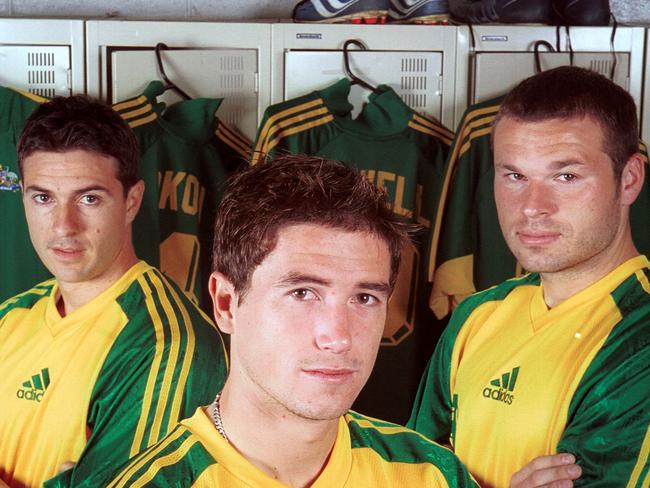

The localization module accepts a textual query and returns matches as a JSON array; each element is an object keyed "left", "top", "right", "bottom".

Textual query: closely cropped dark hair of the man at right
[{"left": 492, "top": 66, "right": 639, "bottom": 179}]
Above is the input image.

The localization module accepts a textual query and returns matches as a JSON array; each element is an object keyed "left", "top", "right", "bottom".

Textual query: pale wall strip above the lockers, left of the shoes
[{"left": 0, "top": 0, "right": 296, "bottom": 20}]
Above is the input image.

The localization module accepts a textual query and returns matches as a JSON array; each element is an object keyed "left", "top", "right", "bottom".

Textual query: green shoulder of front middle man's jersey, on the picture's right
[{"left": 345, "top": 411, "right": 472, "bottom": 486}]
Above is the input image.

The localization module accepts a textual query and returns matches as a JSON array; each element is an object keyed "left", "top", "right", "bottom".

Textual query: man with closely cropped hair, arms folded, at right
[{"left": 409, "top": 67, "right": 650, "bottom": 487}]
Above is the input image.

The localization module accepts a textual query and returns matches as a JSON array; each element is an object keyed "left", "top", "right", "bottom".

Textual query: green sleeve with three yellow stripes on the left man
[{"left": 44, "top": 275, "right": 227, "bottom": 488}]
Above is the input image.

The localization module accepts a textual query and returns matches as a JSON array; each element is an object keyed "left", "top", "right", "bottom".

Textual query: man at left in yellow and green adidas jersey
[{"left": 0, "top": 96, "right": 226, "bottom": 488}]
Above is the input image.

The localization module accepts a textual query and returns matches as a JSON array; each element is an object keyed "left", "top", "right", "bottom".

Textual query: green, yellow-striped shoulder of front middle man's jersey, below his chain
[{"left": 108, "top": 425, "right": 216, "bottom": 488}]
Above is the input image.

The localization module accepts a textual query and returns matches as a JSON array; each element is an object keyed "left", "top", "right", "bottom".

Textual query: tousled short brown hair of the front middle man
[{"left": 212, "top": 155, "right": 408, "bottom": 300}]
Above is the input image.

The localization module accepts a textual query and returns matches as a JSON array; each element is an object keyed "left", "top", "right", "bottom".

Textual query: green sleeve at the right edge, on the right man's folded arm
[{"left": 557, "top": 307, "right": 650, "bottom": 488}]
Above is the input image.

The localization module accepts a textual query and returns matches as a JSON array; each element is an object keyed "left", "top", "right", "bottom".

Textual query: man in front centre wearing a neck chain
[{"left": 108, "top": 156, "right": 475, "bottom": 487}]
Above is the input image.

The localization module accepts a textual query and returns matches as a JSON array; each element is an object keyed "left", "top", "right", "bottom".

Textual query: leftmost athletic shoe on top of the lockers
[{"left": 293, "top": 0, "right": 389, "bottom": 24}]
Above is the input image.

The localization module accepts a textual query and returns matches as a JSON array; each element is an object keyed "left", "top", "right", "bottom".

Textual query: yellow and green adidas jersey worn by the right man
[{"left": 408, "top": 256, "right": 650, "bottom": 487}]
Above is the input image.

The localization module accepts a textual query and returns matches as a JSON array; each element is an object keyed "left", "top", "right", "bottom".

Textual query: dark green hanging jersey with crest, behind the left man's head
[{"left": 0, "top": 86, "right": 52, "bottom": 303}]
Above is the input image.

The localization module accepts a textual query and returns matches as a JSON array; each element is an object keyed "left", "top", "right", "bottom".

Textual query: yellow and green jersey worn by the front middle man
[{"left": 108, "top": 409, "right": 477, "bottom": 488}]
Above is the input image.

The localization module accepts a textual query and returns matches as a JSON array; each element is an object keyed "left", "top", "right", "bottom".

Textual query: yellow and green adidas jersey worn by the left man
[{"left": 0, "top": 261, "right": 227, "bottom": 488}]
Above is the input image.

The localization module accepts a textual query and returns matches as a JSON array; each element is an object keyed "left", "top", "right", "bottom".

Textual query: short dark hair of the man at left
[{"left": 18, "top": 95, "right": 140, "bottom": 194}]
